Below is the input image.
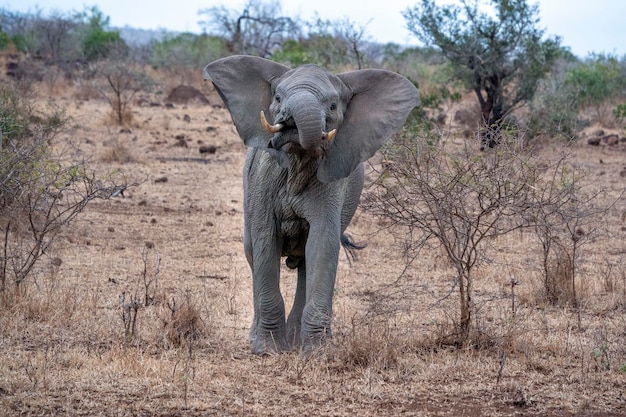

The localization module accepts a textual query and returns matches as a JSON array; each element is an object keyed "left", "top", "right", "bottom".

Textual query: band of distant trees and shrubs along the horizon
[{"left": 0, "top": 0, "right": 626, "bottom": 136}]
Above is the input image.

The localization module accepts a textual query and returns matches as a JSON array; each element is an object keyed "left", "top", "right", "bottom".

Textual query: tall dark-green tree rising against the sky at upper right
[{"left": 403, "top": 0, "right": 561, "bottom": 147}]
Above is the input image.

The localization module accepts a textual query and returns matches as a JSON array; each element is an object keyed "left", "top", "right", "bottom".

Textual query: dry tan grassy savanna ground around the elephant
[{"left": 0, "top": 75, "right": 626, "bottom": 416}]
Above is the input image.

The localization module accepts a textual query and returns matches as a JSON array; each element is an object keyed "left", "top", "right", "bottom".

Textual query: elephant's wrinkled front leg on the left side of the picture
[{"left": 249, "top": 230, "right": 288, "bottom": 354}]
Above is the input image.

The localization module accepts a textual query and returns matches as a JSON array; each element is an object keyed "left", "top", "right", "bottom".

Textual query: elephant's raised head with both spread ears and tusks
[{"left": 204, "top": 56, "right": 419, "bottom": 183}]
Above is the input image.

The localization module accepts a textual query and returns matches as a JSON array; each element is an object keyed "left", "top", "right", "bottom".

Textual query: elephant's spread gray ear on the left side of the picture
[{"left": 204, "top": 55, "right": 290, "bottom": 148}]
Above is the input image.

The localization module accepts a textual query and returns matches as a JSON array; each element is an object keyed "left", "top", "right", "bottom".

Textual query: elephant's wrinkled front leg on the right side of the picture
[{"left": 300, "top": 223, "right": 340, "bottom": 350}]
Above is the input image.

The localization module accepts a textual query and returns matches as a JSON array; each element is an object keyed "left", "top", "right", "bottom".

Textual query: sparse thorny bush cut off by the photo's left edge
[{"left": 0, "top": 85, "right": 130, "bottom": 302}]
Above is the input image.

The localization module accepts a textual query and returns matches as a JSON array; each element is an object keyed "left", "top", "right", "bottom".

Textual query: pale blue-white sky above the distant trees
[{"left": 0, "top": 0, "right": 626, "bottom": 58}]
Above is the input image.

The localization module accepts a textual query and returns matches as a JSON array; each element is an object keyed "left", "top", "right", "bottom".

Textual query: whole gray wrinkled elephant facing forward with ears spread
[{"left": 204, "top": 56, "right": 419, "bottom": 354}]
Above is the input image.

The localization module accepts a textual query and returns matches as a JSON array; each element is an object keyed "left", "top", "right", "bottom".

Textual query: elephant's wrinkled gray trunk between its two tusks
[{"left": 290, "top": 92, "right": 328, "bottom": 155}]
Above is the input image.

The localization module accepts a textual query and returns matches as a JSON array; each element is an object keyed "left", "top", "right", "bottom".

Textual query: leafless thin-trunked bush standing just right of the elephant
[{"left": 366, "top": 136, "right": 534, "bottom": 344}]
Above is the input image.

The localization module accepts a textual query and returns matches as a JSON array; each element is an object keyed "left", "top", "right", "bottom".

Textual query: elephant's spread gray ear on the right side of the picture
[{"left": 317, "top": 69, "right": 420, "bottom": 183}]
